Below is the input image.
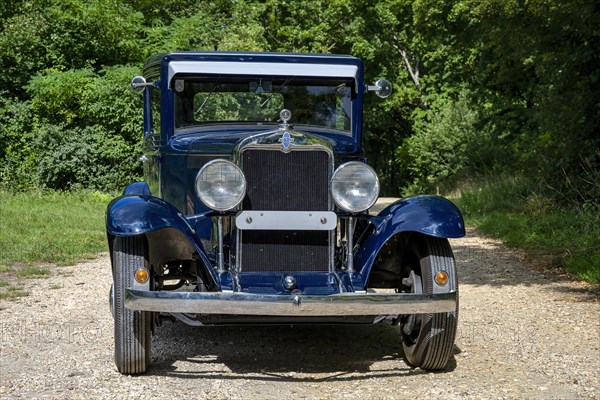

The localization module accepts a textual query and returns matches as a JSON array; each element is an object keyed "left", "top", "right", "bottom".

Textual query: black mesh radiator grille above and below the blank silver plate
[{"left": 239, "top": 148, "right": 332, "bottom": 272}]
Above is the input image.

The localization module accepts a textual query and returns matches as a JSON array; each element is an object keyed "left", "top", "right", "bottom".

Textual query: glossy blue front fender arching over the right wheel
[{"left": 354, "top": 196, "right": 465, "bottom": 282}]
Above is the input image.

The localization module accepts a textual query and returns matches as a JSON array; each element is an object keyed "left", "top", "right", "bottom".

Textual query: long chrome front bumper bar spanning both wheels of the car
[{"left": 125, "top": 288, "right": 457, "bottom": 317}]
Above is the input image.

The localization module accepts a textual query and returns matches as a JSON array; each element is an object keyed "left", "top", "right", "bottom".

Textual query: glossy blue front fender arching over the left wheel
[{"left": 106, "top": 194, "right": 219, "bottom": 285}]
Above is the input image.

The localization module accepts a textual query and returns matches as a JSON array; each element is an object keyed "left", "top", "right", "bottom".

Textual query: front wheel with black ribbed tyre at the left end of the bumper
[{"left": 113, "top": 236, "right": 152, "bottom": 374}]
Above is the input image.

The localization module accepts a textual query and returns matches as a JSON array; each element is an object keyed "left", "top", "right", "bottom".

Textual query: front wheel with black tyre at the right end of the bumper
[{"left": 401, "top": 236, "right": 458, "bottom": 370}]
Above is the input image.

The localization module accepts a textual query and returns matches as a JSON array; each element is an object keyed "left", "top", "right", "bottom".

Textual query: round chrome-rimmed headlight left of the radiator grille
[{"left": 196, "top": 160, "right": 246, "bottom": 211}]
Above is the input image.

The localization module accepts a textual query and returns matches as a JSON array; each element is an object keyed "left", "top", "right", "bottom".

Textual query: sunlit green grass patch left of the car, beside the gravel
[{"left": 0, "top": 191, "right": 112, "bottom": 268}]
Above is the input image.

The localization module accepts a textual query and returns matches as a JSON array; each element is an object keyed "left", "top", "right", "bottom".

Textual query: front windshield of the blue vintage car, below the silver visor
[{"left": 172, "top": 76, "right": 353, "bottom": 134}]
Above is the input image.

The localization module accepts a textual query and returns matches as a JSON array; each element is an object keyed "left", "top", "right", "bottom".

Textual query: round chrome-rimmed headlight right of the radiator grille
[{"left": 331, "top": 161, "right": 379, "bottom": 212}]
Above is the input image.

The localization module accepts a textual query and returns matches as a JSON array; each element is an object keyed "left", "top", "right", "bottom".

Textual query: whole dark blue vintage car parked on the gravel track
[{"left": 106, "top": 52, "right": 465, "bottom": 374}]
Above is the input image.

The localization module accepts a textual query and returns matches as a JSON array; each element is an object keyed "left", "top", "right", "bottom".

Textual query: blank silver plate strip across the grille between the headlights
[{"left": 235, "top": 210, "right": 337, "bottom": 231}]
